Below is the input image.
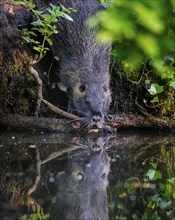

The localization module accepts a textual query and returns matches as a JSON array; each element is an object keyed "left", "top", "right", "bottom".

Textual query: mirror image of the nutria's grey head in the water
[{"left": 50, "top": 138, "right": 109, "bottom": 220}]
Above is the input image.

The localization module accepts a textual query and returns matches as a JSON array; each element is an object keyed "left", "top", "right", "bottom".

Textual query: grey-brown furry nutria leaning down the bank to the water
[{"left": 52, "top": 0, "right": 111, "bottom": 128}]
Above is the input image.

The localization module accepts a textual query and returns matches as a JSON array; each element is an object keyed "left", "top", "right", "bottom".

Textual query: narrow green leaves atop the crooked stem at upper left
[{"left": 15, "top": 0, "right": 74, "bottom": 62}]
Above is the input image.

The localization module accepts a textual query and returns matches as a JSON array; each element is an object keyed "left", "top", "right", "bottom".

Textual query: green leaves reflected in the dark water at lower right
[{"left": 109, "top": 153, "right": 175, "bottom": 220}]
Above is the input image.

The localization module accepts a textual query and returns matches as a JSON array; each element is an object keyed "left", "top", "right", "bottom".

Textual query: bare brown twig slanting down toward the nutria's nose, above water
[{"left": 42, "top": 99, "right": 81, "bottom": 120}]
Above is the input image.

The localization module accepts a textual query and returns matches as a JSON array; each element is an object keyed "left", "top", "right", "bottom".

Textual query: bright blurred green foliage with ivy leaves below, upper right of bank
[{"left": 95, "top": 0, "right": 175, "bottom": 116}]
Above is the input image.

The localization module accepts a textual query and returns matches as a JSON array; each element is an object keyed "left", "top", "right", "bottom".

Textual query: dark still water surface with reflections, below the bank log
[{"left": 0, "top": 131, "right": 175, "bottom": 220}]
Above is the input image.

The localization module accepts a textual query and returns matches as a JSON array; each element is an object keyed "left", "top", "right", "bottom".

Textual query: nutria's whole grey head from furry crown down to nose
[{"left": 60, "top": 53, "right": 111, "bottom": 128}]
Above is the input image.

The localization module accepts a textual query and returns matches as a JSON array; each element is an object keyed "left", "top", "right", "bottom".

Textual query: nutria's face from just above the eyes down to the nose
[{"left": 71, "top": 78, "right": 111, "bottom": 128}]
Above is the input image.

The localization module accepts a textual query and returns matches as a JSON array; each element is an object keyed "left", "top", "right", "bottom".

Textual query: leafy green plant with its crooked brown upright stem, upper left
[{"left": 15, "top": 0, "right": 75, "bottom": 115}]
